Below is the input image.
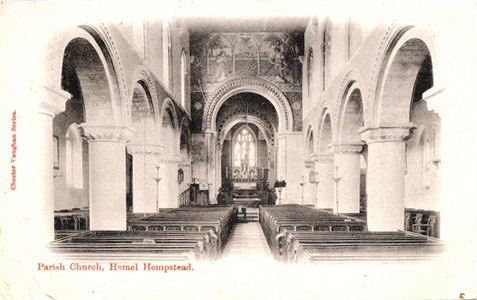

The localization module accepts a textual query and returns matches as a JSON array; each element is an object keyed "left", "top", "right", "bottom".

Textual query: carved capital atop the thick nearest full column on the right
[{"left": 359, "top": 123, "right": 416, "bottom": 144}]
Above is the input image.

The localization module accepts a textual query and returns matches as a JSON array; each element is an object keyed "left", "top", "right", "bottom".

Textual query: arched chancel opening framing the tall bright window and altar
[{"left": 216, "top": 93, "right": 278, "bottom": 189}]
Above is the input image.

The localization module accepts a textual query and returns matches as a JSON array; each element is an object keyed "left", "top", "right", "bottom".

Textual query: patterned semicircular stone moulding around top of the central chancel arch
[{"left": 202, "top": 77, "right": 293, "bottom": 132}]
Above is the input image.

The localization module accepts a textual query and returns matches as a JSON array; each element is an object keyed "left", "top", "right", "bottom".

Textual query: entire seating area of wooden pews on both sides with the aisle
[{"left": 50, "top": 204, "right": 444, "bottom": 263}]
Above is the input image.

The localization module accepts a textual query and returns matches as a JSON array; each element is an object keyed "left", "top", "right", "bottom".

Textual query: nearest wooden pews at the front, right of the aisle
[{"left": 279, "top": 231, "right": 444, "bottom": 263}]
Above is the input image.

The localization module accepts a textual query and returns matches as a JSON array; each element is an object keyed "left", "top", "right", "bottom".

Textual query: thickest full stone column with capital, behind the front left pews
[{"left": 81, "top": 123, "right": 132, "bottom": 230}]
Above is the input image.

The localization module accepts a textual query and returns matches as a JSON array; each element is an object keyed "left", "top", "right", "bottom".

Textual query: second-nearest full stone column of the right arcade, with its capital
[{"left": 332, "top": 145, "right": 363, "bottom": 213}]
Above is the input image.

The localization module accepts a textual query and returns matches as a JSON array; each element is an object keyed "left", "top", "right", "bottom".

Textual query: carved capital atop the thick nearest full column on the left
[{"left": 81, "top": 123, "right": 134, "bottom": 143}]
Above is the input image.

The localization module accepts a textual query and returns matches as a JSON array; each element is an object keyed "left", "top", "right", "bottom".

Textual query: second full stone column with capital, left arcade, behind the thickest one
[{"left": 127, "top": 145, "right": 164, "bottom": 213}]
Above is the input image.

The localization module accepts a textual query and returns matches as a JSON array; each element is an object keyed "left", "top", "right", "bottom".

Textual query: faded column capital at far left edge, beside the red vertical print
[{"left": 34, "top": 86, "right": 71, "bottom": 117}]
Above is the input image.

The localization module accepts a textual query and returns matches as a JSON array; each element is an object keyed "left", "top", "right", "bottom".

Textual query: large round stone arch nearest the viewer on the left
[{"left": 41, "top": 25, "right": 129, "bottom": 125}]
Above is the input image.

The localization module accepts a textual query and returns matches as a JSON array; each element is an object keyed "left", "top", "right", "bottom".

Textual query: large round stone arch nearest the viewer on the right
[{"left": 373, "top": 26, "right": 438, "bottom": 126}]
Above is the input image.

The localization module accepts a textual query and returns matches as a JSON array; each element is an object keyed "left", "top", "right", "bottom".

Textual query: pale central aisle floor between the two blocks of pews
[{"left": 222, "top": 222, "right": 273, "bottom": 260}]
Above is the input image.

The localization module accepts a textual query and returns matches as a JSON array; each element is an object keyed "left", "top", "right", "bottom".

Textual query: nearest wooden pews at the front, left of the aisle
[{"left": 50, "top": 231, "right": 218, "bottom": 261}]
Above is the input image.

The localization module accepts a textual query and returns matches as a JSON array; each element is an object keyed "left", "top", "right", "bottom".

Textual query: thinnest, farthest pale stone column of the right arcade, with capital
[{"left": 312, "top": 154, "right": 333, "bottom": 209}]
